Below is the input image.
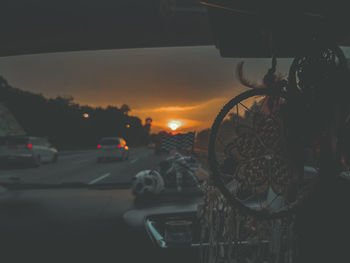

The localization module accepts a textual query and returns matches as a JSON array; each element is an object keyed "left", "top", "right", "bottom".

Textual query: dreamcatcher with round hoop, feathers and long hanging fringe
[{"left": 198, "top": 43, "right": 344, "bottom": 263}]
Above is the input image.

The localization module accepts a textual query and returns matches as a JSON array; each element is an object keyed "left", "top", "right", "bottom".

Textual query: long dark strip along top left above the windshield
[{"left": 0, "top": 0, "right": 212, "bottom": 56}]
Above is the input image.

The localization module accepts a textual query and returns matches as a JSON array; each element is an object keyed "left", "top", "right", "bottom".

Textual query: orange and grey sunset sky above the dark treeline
[{"left": 0, "top": 46, "right": 348, "bottom": 132}]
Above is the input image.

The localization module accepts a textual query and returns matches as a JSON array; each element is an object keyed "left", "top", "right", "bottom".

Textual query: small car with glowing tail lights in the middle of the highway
[{"left": 97, "top": 137, "right": 129, "bottom": 162}]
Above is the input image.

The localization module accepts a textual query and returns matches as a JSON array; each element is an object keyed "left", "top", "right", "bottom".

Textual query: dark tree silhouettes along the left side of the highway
[{"left": 0, "top": 76, "right": 149, "bottom": 149}]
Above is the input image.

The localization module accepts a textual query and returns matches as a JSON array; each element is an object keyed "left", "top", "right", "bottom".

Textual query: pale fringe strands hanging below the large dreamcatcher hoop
[{"left": 197, "top": 181, "right": 272, "bottom": 263}]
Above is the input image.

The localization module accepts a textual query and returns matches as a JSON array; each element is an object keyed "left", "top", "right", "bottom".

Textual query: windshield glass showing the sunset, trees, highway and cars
[{"left": 0, "top": 46, "right": 347, "bottom": 187}]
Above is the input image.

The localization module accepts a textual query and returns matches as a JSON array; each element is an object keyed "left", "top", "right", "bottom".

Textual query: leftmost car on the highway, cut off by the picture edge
[{"left": 0, "top": 136, "right": 58, "bottom": 167}]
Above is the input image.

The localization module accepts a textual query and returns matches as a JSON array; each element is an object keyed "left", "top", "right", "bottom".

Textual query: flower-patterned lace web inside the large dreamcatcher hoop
[{"left": 226, "top": 112, "right": 294, "bottom": 196}]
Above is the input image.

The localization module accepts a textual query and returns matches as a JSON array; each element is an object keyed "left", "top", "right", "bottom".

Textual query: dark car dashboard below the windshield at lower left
[{"left": 0, "top": 188, "right": 201, "bottom": 262}]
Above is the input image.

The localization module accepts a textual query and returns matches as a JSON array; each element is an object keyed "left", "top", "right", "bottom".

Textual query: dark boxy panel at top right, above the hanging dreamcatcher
[{"left": 201, "top": 0, "right": 350, "bottom": 58}]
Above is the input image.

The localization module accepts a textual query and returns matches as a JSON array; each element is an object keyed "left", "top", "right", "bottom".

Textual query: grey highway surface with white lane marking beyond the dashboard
[{"left": 0, "top": 147, "right": 164, "bottom": 184}]
